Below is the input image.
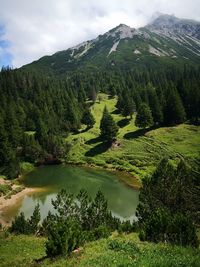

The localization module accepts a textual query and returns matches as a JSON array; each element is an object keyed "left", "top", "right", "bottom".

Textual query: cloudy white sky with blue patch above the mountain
[{"left": 0, "top": 0, "right": 200, "bottom": 68}]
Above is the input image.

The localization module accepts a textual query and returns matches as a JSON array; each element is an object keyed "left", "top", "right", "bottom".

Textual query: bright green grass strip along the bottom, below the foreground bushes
[{"left": 0, "top": 233, "right": 200, "bottom": 267}]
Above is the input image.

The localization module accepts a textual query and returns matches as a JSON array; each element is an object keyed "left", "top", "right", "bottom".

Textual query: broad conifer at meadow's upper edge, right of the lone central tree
[{"left": 135, "top": 103, "right": 153, "bottom": 128}]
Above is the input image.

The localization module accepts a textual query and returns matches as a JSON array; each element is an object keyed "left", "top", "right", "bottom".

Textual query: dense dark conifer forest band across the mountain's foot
[{"left": 0, "top": 66, "right": 200, "bottom": 178}]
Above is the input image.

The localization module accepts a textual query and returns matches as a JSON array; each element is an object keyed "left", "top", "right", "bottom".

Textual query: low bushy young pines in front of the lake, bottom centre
[{"left": 41, "top": 190, "right": 133, "bottom": 257}]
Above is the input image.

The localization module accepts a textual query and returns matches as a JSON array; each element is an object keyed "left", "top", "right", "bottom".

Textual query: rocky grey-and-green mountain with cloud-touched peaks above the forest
[{"left": 25, "top": 14, "right": 200, "bottom": 74}]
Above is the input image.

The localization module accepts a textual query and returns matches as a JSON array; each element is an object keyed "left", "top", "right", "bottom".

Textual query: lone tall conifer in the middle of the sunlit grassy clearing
[{"left": 100, "top": 107, "right": 118, "bottom": 142}]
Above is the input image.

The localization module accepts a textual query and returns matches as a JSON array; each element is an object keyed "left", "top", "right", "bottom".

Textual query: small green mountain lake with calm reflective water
[{"left": 2, "top": 165, "right": 139, "bottom": 223}]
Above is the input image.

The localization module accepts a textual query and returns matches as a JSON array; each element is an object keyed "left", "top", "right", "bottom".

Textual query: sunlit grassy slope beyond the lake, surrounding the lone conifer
[{"left": 67, "top": 94, "right": 200, "bottom": 184}]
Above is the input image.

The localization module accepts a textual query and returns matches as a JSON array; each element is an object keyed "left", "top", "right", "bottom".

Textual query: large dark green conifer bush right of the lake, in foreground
[{"left": 137, "top": 159, "right": 199, "bottom": 246}]
